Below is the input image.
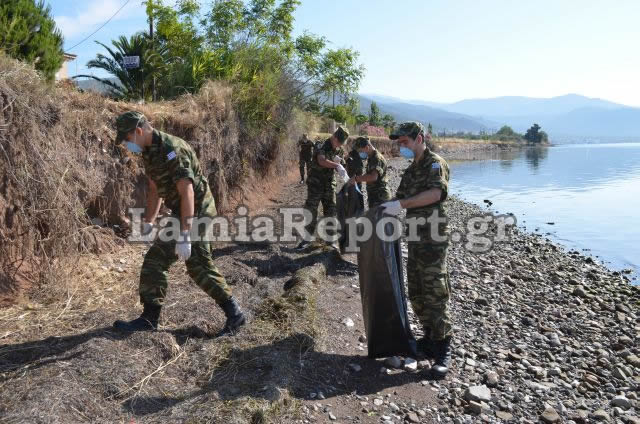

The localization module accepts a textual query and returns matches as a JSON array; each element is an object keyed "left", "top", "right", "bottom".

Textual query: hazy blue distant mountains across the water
[{"left": 360, "top": 94, "right": 640, "bottom": 141}]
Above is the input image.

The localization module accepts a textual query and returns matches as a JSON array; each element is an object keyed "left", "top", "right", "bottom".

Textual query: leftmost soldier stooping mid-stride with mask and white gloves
[{"left": 114, "top": 111, "right": 246, "bottom": 337}]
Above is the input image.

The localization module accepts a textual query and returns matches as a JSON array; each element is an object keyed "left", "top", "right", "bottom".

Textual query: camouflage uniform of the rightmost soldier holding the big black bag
[{"left": 394, "top": 123, "right": 452, "bottom": 340}]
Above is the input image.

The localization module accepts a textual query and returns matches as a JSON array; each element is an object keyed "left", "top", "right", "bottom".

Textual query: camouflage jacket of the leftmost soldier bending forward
[{"left": 142, "top": 130, "right": 216, "bottom": 216}]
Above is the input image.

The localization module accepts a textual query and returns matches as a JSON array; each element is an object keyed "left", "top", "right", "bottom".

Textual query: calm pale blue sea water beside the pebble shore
[{"left": 450, "top": 143, "right": 640, "bottom": 284}]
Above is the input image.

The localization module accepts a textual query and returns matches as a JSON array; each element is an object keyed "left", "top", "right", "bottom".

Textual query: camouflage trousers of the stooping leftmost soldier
[{"left": 139, "top": 227, "right": 231, "bottom": 306}]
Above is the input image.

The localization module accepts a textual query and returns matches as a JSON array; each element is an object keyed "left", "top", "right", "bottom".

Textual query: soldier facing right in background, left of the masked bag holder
[{"left": 298, "top": 127, "right": 349, "bottom": 248}]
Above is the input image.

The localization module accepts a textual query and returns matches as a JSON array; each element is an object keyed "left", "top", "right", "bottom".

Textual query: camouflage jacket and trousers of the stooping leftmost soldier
[{"left": 139, "top": 130, "right": 231, "bottom": 306}]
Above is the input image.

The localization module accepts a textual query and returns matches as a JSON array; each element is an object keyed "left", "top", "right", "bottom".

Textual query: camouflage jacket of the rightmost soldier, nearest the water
[{"left": 396, "top": 150, "right": 449, "bottom": 242}]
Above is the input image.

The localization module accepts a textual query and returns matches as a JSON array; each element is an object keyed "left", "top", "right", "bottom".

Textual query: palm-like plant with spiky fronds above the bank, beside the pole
[{"left": 74, "top": 32, "right": 166, "bottom": 100}]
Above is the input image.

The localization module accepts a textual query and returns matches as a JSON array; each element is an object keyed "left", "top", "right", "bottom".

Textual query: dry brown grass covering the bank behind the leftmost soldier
[{"left": 0, "top": 55, "right": 308, "bottom": 302}]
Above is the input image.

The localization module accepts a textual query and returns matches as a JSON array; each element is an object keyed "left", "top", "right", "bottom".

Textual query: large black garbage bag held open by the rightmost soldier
[{"left": 358, "top": 207, "right": 416, "bottom": 358}]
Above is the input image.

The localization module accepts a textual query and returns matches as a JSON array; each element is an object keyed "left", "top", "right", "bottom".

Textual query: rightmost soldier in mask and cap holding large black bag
[{"left": 382, "top": 122, "right": 452, "bottom": 377}]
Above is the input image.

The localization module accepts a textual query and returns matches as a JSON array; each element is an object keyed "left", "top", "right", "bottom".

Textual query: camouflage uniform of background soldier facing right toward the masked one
[{"left": 304, "top": 127, "right": 349, "bottom": 235}]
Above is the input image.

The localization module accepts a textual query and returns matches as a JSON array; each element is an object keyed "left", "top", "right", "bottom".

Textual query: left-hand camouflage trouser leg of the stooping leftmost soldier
[{"left": 138, "top": 240, "right": 178, "bottom": 306}]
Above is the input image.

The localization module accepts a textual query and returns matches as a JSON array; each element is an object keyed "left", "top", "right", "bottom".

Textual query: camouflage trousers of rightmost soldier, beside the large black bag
[{"left": 407, "top": 243, "right": 453, "bottom": 340}]
